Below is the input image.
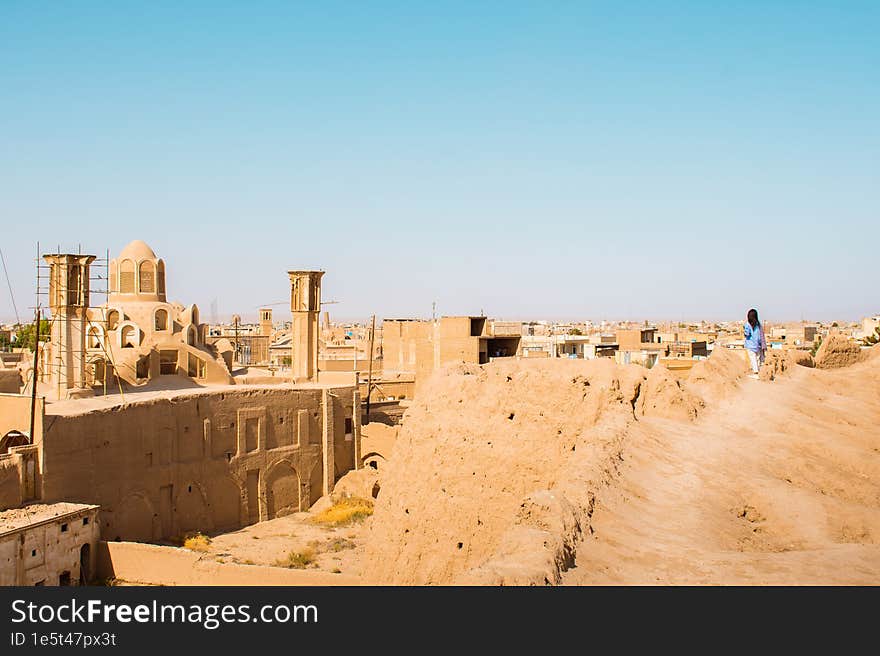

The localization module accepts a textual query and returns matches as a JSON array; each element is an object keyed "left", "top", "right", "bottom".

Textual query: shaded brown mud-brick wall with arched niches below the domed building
[{"left": 43, "top": 387, "right": 359, "bottom": 541}]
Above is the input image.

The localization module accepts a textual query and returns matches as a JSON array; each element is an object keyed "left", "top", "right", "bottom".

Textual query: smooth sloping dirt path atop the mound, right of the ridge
[{"left": 564, "top": 365, "right": 880, "bottom": 585}]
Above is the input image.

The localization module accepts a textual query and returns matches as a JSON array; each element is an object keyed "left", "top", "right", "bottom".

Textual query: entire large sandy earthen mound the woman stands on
[{"left": 362, "top": 347, "right": 880, "bottom": 585}]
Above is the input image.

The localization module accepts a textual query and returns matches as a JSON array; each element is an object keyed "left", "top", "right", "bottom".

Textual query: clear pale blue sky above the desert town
[{"left": 0, "top": 0, "right": 880, "bottom": 320}]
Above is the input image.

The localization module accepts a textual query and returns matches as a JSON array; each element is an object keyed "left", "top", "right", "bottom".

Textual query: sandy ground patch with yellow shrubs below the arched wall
[{"left": 194, "top": 512, "right": 371, "bottom": 576}]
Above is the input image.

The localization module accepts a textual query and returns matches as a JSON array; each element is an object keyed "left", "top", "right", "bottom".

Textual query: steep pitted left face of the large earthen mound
[{"left": 365, "top": 359, "right": 646, "bottom": 584}]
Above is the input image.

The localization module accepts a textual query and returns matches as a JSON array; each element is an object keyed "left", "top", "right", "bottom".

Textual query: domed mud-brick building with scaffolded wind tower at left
[{"left": 40, "top": 240, "right": 231, "bottom": 398}]
